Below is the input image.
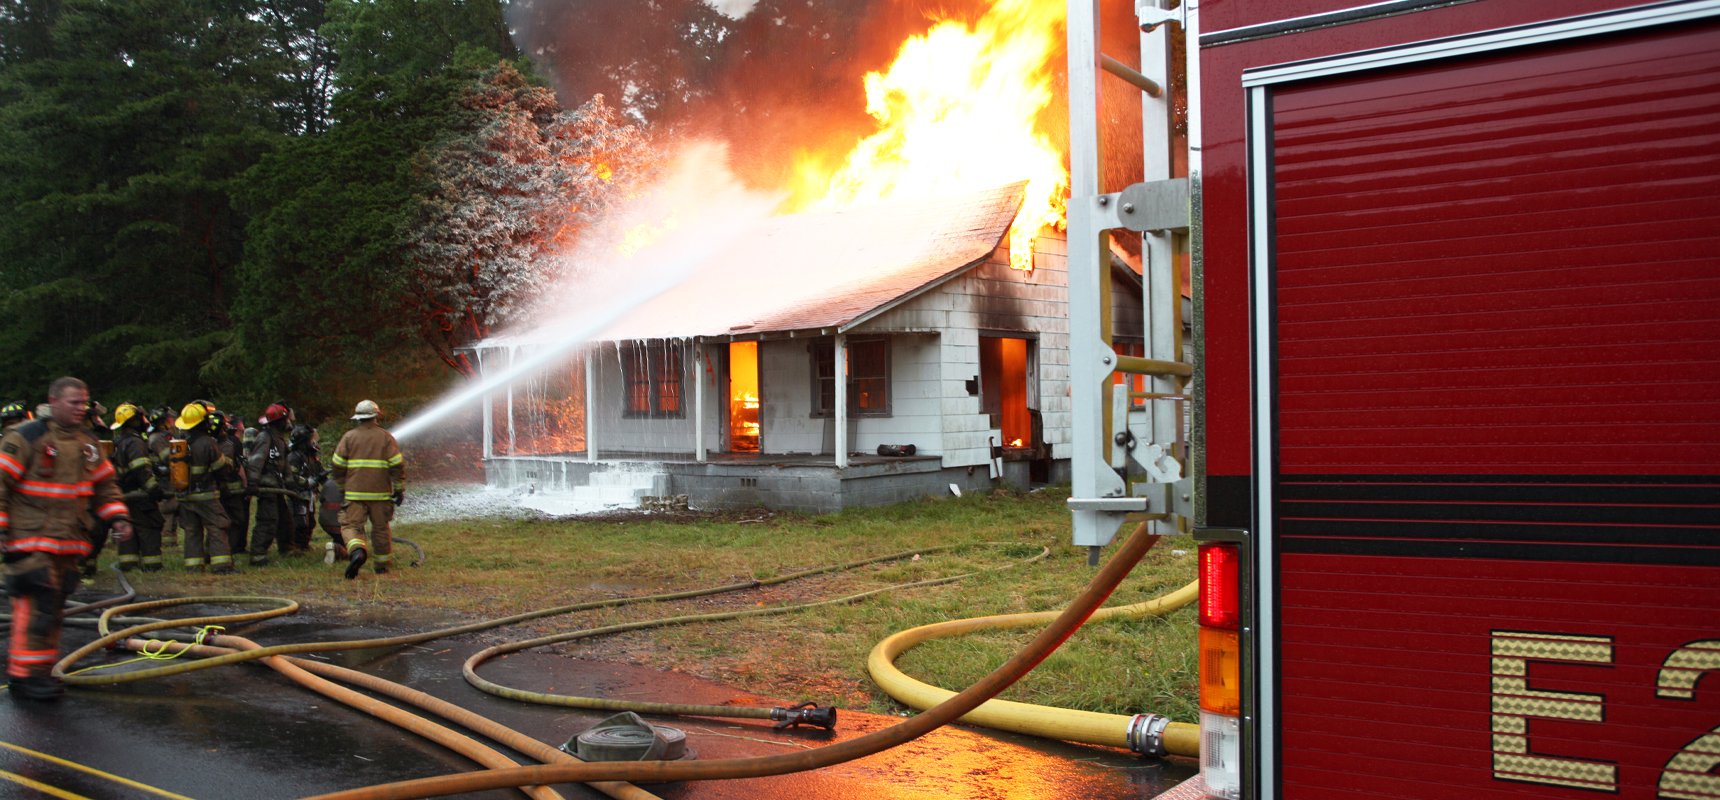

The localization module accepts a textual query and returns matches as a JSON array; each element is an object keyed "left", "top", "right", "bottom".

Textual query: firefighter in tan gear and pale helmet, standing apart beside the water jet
[{"left": 332, "top": 399, "right": 406, "bottom": 580}]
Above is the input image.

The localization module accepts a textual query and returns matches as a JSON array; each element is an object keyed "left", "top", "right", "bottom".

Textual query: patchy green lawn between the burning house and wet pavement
[{"left": 101, "top": 490, "right": 1195, "bottom": 723}]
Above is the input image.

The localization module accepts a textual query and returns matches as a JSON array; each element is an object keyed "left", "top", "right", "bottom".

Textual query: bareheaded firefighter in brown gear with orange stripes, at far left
[{"left": 0, "top": 377, "right": 131, "bottom": 700}]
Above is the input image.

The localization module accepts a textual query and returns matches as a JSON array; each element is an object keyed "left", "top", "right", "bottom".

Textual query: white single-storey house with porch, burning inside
[{"left": 473, "top": 184, "right": 1142, "bottom": 511}]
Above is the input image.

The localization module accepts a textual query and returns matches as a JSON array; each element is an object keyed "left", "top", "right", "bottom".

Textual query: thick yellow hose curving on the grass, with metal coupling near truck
[{"left": 867, "top": 582, "right": 1201, "bottom": 757}]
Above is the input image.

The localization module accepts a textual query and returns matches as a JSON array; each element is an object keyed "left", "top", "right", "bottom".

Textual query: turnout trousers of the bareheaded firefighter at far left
[{"left": 5, "top": 552, "right": 77, "bottom": 678}]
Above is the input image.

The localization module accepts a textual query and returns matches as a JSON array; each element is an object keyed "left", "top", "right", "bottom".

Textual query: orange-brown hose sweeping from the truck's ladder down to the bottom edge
[{"left": 295, "top": 525, "right": 1158, "bottom": 800}]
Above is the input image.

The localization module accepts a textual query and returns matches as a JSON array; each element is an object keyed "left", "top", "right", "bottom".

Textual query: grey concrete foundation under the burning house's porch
[{"left": 485, "top": 454, "right": 1070, "bottom": 514}]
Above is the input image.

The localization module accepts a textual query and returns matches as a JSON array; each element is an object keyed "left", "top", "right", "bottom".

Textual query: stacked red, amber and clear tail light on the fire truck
[{"left": 1201, "top": 542, "right": 1242, "bottom": 800}]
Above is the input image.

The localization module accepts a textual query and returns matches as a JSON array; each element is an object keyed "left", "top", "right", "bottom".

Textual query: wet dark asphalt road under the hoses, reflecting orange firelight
[{"left": 0, "top": 584, "right": 1195, "bottom": 800}]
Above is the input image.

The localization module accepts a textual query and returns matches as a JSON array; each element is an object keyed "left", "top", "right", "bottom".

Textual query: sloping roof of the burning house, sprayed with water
[{"left": 473, "top": 182, "right": 1025, "bottom": 349}]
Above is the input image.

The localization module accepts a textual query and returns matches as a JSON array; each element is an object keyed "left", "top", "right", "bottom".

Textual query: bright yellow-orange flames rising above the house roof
[{"left": 795, "top": 0, "right": 1068, "bottom": 270}]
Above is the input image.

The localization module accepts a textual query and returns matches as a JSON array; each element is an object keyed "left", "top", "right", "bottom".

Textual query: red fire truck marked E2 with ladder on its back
[{"left": 1068, "top": 0, "right": 1720, "bottom": 800}]
